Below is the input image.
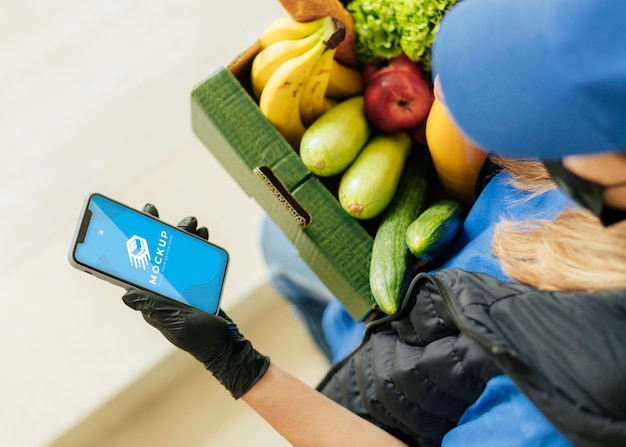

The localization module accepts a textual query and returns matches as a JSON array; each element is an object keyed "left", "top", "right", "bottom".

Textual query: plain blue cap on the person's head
[{"left": 432, "top": 0, "right": 626, "bottom": 160}]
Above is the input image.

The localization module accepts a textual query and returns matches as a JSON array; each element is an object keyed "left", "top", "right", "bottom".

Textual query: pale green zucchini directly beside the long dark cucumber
[{"left": 338, "top": 133, "right": 412, "bottom": 219}]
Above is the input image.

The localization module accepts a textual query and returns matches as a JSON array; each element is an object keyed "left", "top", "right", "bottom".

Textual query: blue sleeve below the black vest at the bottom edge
[{"left": 442, "top": 376, "right": 574, "bottom": 447}]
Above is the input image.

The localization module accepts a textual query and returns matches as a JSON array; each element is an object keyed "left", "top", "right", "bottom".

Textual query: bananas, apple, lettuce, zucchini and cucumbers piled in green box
[{"left": 251, "top": 0, "right": 464, "bottom": 314}]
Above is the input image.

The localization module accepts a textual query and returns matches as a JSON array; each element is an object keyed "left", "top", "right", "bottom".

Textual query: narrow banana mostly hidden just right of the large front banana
[{"left": 300, "top": 44, "right": 337, "bottom": 127}]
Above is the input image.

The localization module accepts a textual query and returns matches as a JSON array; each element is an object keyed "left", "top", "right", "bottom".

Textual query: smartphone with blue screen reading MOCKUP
[{"left": 69, "top": 193, "right": 228, "bottom": 314}]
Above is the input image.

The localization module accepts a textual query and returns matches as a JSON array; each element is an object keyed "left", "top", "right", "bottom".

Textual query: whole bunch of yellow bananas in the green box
[{"left": 251, "top": 17, "right": 363, "bottom": 149}]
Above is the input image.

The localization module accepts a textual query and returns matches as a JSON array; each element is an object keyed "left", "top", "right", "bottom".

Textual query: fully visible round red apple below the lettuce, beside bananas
[{"left": 363, "top": 69, "right": 434, "bottom": 133}]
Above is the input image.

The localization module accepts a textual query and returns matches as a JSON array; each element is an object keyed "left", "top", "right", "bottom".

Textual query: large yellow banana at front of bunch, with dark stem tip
[{"left": 259, "top": 17, "right": 345, "bottom": 150}]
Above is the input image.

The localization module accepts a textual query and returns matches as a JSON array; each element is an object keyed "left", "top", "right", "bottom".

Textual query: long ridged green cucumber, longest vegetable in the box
[{"left": 369, "top": 149, "right": 434, "bottom": 314}]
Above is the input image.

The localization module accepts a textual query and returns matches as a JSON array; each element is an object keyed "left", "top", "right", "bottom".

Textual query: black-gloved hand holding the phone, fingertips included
[{"left": 122, "top": 205, "right": 270, "bottom": 399}]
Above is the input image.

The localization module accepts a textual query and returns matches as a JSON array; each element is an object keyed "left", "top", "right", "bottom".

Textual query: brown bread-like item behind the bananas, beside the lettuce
[{"left": 279, "top": 0, "right": 362, "bottom": 68}]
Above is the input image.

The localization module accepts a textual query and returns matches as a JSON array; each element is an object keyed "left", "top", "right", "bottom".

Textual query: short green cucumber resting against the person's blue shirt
[{"left": 406, "top": 199, "right": 463, "bottom": 261}]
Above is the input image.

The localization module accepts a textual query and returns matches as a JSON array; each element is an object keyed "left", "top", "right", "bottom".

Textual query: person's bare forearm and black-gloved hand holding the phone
[{"left": 123, "top": 205, "right": 405, "bottom": 447}]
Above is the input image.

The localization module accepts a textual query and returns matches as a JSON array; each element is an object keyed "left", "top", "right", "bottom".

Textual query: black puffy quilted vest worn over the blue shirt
[{"left": 318, "top": 269, "right": 626, "bottom": 447}]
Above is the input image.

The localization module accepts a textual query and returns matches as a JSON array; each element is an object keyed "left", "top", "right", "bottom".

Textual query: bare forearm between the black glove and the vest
[{"left": 242, "top": 364, "right": 406, "bottom": 447}]
